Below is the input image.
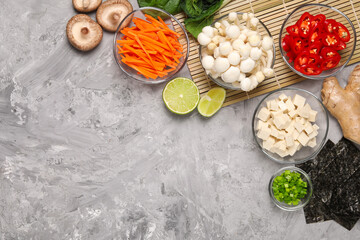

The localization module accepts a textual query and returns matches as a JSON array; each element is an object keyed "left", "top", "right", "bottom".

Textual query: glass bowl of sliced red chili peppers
[{"left": 279, "top": 3, "right": 356, "bottom": 80}]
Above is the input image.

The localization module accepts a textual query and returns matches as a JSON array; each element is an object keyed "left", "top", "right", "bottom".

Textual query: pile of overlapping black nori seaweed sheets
[{"left": 297, "top": 138, "right": 360, "bottom": 230}]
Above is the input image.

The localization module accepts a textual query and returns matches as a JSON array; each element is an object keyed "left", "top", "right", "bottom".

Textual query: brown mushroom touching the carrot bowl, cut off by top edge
[{"left": 96, "top": 0, "right": 133, "bottom": 32}]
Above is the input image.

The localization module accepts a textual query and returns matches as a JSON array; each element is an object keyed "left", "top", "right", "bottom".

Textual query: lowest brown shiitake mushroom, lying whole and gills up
[{"left": 66, "top": 14, "right": 103, "bottom": 51}]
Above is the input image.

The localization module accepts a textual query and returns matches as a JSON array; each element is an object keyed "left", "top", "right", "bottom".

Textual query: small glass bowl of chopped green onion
[{"left": 269, "top": 166, "right": 313, "bottom": 211}]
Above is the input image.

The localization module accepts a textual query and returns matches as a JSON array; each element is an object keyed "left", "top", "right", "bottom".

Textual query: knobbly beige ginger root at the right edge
[{"left": 321, "top": 65, "right": 360, "bottom": 144}]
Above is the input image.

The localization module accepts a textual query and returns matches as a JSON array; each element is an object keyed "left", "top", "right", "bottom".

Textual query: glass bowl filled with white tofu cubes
[{"left": 252, "top": 88, "right": 329, "bottom": 164}]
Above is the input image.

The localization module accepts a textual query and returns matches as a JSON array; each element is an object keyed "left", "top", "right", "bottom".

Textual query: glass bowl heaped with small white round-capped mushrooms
[{"left": 197, "top": 12, "right": 275, "bottom": 92}]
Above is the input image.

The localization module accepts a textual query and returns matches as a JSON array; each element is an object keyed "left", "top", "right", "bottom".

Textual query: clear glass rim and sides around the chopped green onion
[{"left": 269, "top": 166, "right": 313, "bottom": 211}]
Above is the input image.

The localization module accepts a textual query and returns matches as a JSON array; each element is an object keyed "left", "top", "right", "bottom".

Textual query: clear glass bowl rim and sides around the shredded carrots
[{"left": 113, "top": 7, "right": 190, "bottom": 84}]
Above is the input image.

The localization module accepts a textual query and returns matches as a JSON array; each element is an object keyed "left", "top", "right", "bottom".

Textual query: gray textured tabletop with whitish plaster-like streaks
[{"left": 0, "top": 0, "right": 360, "bottom": 240}]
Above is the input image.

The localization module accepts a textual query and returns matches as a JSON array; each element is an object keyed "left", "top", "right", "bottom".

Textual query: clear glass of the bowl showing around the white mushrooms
[{"left": 199, "top": 12, "right": 276, "bottom": 90}]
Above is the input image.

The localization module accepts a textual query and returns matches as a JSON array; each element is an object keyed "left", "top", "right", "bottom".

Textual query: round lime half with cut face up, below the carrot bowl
[{"left": 163, "top": 78, "right": 200, "bottom": 114}]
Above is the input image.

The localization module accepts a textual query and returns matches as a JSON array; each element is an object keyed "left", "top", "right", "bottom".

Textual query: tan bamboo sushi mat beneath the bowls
[{"left": 171, "top": 0, "right": 360, "bottom": 106}]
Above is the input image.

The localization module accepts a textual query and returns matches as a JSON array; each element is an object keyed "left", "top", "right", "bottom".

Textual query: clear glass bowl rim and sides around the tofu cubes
[{"left": 252, "top": 88, "right": 329, "bottom": 164}]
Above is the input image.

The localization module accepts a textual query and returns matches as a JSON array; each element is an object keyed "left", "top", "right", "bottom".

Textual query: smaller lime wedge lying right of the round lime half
[{"left": 198, "top": 87, "right": 226, "bottom": 117}]
